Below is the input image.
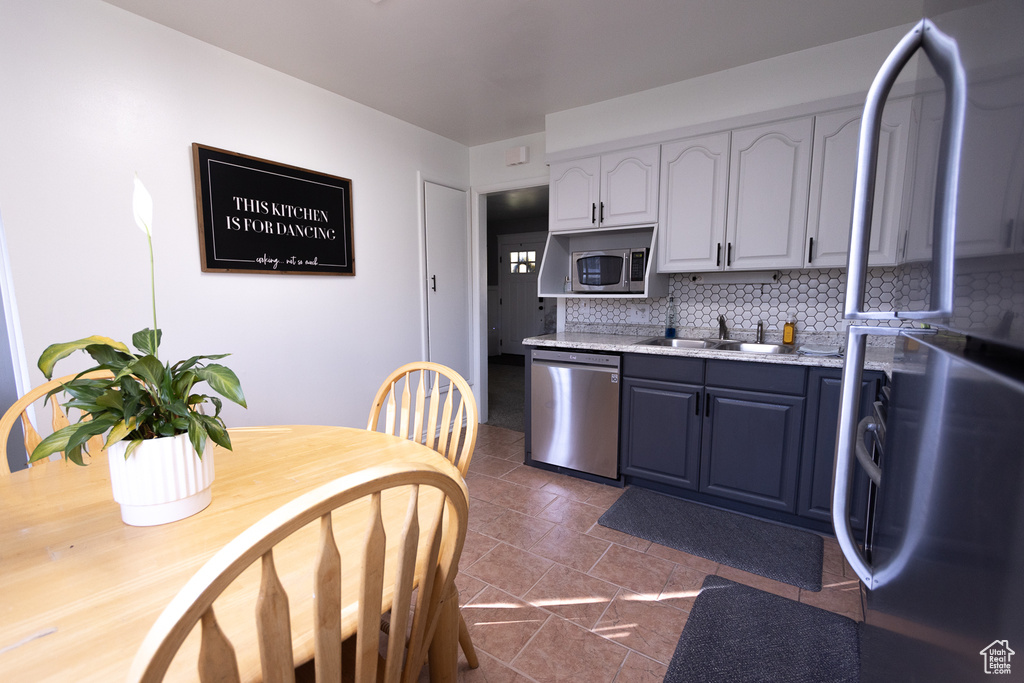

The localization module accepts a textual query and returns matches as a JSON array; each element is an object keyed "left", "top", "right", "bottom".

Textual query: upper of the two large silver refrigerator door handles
[{"left": 844, "top": 18, "right": 967, "bottom": 321}]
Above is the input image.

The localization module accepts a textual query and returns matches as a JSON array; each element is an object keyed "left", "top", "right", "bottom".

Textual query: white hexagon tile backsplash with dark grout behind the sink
[{"left": 565, "top": 268, "right": 905, "bottom": 334}]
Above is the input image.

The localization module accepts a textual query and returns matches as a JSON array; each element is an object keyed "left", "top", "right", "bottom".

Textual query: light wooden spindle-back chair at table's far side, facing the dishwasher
[{"left": 367, "top": 360, "right": 479, "bottom": 669}]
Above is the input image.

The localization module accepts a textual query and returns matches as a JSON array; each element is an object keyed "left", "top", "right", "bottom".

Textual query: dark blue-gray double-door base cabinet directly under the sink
[{"left": 620, "top": 354, "right": 807, "bottom": 513}]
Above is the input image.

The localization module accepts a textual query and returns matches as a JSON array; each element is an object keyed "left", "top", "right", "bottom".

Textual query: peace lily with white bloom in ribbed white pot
[{"left": 30, "top": 177, "right": 246, "bottom": 526}]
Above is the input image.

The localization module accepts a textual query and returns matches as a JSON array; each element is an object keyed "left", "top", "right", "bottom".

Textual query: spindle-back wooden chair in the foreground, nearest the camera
[{"left": 128, "top": 463, "right": 469, "bottom": 683}]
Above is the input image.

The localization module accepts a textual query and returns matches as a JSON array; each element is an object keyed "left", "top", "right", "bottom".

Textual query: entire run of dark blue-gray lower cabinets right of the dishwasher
[{"left": 620, "top": 353, "right": 884, "bottom": 531}]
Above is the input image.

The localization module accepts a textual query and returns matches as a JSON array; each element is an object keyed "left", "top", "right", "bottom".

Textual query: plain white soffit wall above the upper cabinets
[{"left": 545, "top": 25, "right": 914, "bottom": 154}]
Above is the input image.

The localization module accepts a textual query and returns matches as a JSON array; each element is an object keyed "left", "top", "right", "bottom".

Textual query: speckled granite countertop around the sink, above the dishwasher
[{"left": 522, "top": 332, "right": 893, "bottom": 372}]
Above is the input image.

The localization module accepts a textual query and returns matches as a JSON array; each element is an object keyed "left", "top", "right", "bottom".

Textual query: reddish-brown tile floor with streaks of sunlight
[{"left": 448, "top": 425, "right": 861, "bottom": 683}]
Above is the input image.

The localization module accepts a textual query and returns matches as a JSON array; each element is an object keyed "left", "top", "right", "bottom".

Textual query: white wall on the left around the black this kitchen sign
[{"left": 0, "top": 0, "right": 469, "bottom": 426}]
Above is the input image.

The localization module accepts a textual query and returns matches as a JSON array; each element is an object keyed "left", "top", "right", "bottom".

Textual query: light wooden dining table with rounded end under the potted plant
[{"left": 0, "top": 425, "right": 460, "bottom": 683}]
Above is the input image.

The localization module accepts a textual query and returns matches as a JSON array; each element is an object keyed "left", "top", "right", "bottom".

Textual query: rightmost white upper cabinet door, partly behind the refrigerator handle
[{"left": 804, "top": 99, "right": 910, "bottom": 268}]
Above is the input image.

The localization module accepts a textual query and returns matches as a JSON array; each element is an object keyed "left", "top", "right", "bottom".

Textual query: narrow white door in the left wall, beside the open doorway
[{"left": 423, "top": 181, "right": 474, "bottom": 385}]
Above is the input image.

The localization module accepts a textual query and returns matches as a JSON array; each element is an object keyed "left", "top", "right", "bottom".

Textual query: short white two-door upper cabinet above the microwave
[{"left": 549, "top": 144, "right": 660, "bottom": 232}]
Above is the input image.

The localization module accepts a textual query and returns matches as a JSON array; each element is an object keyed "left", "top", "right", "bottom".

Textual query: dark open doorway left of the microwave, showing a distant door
[{"left": 485, "top": 184, "right": 556, "bottom": 431}]
